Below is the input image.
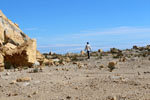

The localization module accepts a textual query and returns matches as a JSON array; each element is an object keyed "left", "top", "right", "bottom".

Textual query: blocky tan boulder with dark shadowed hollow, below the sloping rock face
[{"left": 4, "top": 39, "right": 36, "bottom": 67}]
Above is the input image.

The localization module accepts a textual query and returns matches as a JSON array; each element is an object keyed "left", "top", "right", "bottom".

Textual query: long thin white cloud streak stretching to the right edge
[{"left": 74, "top": 26, "right": 150, "bottom": 38}]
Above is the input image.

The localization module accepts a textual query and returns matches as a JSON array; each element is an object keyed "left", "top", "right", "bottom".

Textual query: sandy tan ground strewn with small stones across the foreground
[{"left": 0, "top": 50, "right": 150, "bottom": 100}]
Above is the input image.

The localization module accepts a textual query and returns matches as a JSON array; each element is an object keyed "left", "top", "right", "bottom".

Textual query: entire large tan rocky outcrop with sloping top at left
[{"left": 0, "top": 10, "right": 43, "bottom": 71}]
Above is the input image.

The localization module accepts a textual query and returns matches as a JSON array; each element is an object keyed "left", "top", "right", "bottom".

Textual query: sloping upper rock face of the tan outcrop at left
[{"left": 0, "top": 11, "right": 30, "bottom": 45}]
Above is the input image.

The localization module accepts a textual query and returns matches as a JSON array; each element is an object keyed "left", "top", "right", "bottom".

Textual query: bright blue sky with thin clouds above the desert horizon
[{"left": 0, "top": 0, "right": 150, "bottom": 53}]
